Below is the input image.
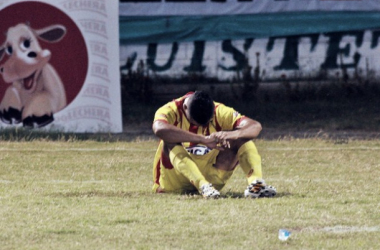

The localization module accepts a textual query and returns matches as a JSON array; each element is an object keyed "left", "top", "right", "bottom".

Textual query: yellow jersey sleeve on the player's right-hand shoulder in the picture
[{"left": 215, "top": 104, "right": 245, "bottom": 130}]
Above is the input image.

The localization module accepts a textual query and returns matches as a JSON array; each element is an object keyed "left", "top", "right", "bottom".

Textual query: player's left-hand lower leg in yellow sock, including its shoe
[{"left": 164, "top": 143, "right": 220, "bottom": 198}]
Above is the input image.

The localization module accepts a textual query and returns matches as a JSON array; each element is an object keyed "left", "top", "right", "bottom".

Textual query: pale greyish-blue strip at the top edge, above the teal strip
[{"left": 120, "top": 0, "right": 380, "bottom": 16}]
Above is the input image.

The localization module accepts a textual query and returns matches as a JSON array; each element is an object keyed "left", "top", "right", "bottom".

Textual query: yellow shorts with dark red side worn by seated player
[{"left": 153, "top": 146, "right": 234, "bottom": 193}]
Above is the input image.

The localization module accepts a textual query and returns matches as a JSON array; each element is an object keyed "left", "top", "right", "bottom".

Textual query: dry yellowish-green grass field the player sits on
[{"left": 0, "top": 139, "right": 380, "bottom": 250}]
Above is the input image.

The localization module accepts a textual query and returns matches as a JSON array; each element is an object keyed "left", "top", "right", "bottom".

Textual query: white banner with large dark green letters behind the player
[{"left": 120, "top": 30, "right": 380, "bottom": 80}]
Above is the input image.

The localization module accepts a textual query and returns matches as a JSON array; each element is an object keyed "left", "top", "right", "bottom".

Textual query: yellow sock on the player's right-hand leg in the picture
[{"left": 238, "top": 141, "right": 263, "bottom": 184}]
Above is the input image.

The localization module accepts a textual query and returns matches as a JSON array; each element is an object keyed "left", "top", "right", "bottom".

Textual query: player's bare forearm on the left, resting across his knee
[{"left": 153, "top": 120, "right": 216, "bottom": 148}]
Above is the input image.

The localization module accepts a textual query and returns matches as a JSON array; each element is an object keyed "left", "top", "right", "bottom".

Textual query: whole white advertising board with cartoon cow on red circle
[{"left": 0, "top": 0, "right": 122, "bottom": 132}]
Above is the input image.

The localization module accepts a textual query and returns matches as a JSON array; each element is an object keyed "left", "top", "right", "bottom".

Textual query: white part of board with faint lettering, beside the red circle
[{"left": 53, "top": 0, "right": 122, "bottom": 132}]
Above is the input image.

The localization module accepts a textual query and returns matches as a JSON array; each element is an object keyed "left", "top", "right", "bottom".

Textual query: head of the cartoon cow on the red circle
[{"left": 0, "top": 24, "right": 66, "bottom": 90}]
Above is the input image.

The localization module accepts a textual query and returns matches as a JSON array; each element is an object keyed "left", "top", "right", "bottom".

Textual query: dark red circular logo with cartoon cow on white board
[{"left": 0, "top": 1, "right": 89, "bottom": 126}]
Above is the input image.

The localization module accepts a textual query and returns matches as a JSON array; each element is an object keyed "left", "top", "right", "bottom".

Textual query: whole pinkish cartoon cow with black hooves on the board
[{"left": 0, "top": 24, "right": 67, "bottom": 128}]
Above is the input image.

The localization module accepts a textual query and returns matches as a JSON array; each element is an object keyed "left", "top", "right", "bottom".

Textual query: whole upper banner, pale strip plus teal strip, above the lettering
[{"left": 119, "top": 0, "right": 380, "bottom": 45}]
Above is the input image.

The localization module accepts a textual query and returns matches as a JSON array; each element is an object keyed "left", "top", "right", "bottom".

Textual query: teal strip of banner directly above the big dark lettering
[{"left": 119, "top": 11, "right": 380, "bottom": 45}]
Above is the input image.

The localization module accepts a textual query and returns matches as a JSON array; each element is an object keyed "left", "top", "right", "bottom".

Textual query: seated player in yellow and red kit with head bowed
[{"left": 153, "top": 91, "right": 276, "bottom": 198}]
